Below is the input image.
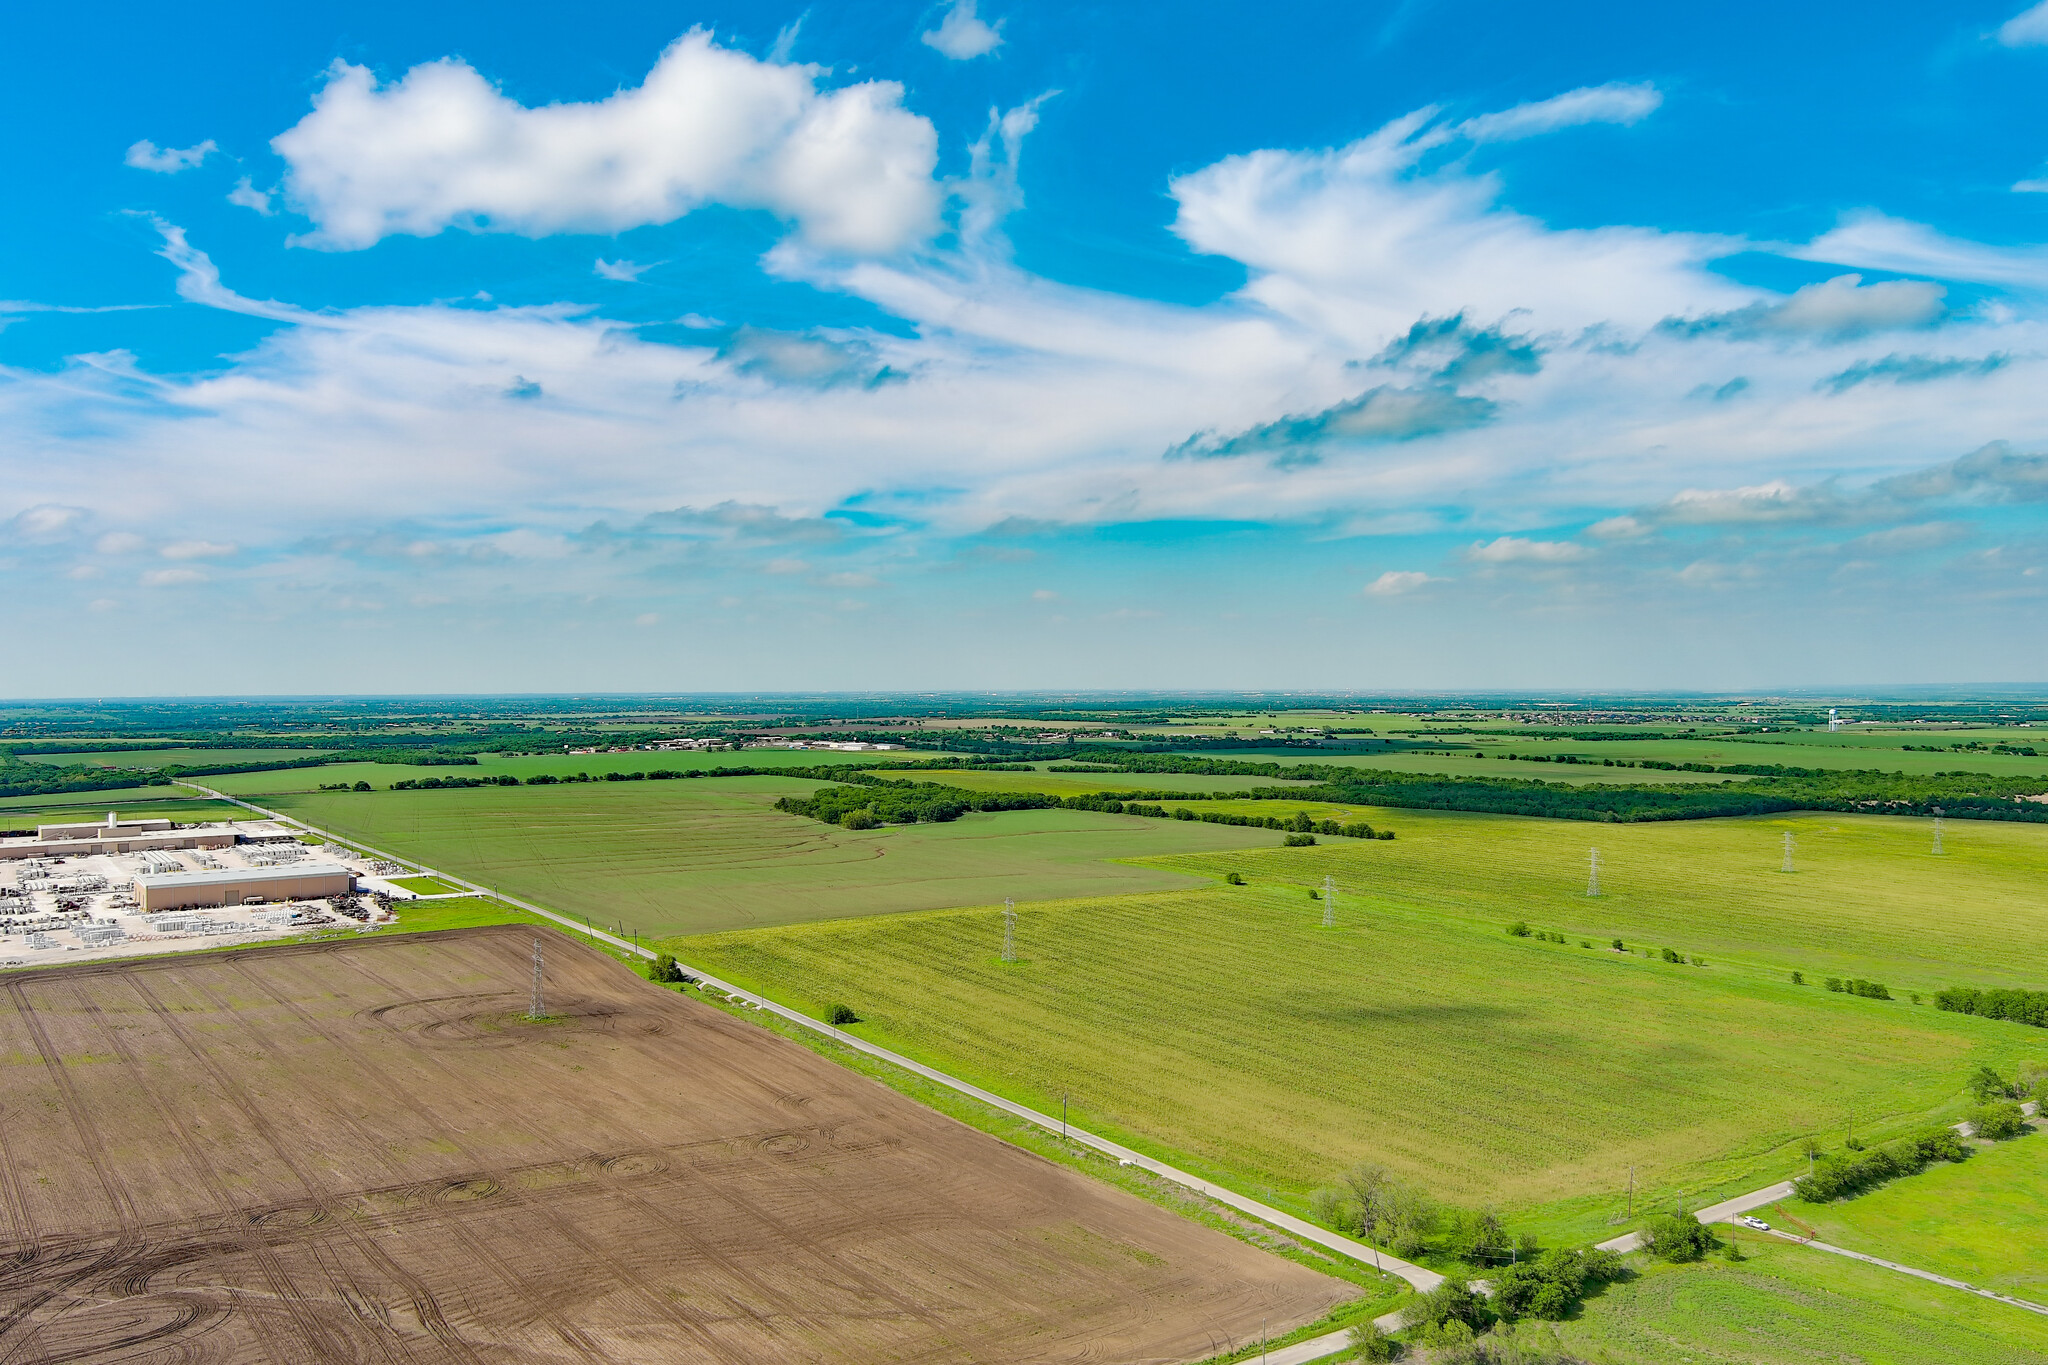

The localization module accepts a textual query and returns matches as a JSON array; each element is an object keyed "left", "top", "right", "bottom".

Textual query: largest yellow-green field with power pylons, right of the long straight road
[{"left": 676, "top": 812, "right": 2048, "bottom": 1236}]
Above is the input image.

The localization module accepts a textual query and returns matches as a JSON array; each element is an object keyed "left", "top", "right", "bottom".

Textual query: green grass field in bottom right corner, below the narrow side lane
[{"left": 1559, "top": 1234, "right": 2048, "bottom": 1365}]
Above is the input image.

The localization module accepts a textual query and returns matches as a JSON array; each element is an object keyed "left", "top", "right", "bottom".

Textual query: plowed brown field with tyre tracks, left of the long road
[{"left": 0, "top": 927, "right": 1354, "bottom": 1365}]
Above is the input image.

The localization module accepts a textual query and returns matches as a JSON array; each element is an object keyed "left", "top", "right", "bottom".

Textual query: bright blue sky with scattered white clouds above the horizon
[{"left": 0, "top": 0, "right": 2048, "bottom": 696}]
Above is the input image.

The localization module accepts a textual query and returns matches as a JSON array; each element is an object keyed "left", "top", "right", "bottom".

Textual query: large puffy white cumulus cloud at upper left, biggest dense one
[{"left": 270, "top": 31, "right": 940, "bottom": 254}]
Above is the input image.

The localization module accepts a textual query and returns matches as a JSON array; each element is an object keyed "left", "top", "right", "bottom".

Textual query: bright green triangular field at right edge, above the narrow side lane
[{"left": 1759, "top": 1129, "right": 2048, "bottom": 1304}]
